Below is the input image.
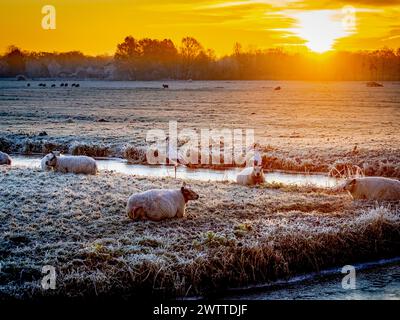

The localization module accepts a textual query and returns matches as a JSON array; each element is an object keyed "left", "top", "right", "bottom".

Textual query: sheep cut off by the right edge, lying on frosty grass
[{"left": 339, "top": 177, "right": 400, "bottom": 200}]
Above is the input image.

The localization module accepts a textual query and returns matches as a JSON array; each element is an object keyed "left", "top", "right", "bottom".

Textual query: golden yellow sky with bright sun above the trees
[{"left": 0, "top": 0, "right": 400, "bottom": 55}]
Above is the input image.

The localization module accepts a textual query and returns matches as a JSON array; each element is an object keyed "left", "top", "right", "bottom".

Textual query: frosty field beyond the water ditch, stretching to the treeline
[{"left": 0, "top": 81, "right": 400, "bottom": 177}]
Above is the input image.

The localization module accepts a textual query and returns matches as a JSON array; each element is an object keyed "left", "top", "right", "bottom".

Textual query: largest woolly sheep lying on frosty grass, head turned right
[{"left": 126, "top": 184, "right": 199, "bottom": 221}]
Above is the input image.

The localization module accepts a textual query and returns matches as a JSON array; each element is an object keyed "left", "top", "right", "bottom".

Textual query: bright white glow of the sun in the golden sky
[{"left": 293, "top": 10, "right": 354, "bottom": 53}]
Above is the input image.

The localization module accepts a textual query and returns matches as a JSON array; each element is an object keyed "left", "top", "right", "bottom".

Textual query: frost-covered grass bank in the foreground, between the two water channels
[{"left": 0, "top": 167, "right": 400, "bottom": 298}]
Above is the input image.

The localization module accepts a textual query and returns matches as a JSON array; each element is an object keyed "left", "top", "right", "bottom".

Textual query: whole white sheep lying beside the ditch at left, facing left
[{"left": 41, "top": 152, "right": 98, "bottom": 175}]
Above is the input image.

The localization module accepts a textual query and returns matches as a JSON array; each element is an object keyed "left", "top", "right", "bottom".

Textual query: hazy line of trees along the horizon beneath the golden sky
[{"left": 0, "top": 36, "right": 400, "bottom": 81}]
